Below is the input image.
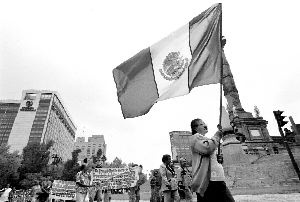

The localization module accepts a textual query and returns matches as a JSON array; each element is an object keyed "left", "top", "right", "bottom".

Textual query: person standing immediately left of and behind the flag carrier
[{"left": 177, "top": 158, "right": 193, "bottom": 202}]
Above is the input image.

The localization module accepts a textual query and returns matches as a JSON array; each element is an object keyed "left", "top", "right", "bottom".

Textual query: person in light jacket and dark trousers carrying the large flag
[{"left": 191, "top": 119, "right": 234, "bottom": 202}]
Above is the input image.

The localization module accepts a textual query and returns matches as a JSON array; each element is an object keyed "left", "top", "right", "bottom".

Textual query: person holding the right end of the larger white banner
[{"left": 128, "top": 164, "right": 147, "bottom": 202}]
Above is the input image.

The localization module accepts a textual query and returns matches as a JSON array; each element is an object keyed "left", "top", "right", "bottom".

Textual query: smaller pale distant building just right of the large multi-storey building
[{"left": 75, "top": 135, "right": 106, "bottom": 161}]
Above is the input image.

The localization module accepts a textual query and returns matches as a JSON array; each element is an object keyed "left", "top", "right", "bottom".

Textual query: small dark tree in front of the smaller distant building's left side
[{"left": 61, "top": 149, "right": 81, "bottom": 181}]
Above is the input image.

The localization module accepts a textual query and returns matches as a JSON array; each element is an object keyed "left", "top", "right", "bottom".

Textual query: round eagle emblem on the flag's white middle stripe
[{"left": 159, "top": 51, "right": 190, "bottom": 81}]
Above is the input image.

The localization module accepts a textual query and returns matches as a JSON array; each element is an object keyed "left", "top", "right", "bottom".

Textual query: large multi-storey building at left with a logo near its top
[{"left": 1, "top": 90, "right": 76, "bottom": 161}]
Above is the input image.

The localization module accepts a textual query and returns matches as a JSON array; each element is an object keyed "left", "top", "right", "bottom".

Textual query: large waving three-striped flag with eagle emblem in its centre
[{"left": 113, "top": 4, "right": 222, "bottom": 118}]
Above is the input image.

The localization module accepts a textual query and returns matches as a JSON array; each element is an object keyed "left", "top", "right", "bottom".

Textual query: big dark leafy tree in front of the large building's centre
[{"left": 19, "top": 141, "right": 54, "bottom": 189}]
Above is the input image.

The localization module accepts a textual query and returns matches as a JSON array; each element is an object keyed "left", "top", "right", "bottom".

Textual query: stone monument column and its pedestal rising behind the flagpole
[{"left": 222, "top": 39, "right": 273, "bottom": 163}]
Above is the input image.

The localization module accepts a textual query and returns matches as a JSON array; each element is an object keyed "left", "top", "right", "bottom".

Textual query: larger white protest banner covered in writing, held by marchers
[{"left": 92, "top": 167, "right": 139, "bottom": 190}]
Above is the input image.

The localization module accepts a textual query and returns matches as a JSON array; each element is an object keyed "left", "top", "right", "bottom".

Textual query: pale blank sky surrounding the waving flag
[{"left": 0, "top": 0, "right": 300, "bottom": 174}]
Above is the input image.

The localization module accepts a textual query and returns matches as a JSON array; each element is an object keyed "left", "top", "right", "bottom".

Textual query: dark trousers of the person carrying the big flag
[{"left": 196, "top": 181, "right": 234, "bottom": 202}]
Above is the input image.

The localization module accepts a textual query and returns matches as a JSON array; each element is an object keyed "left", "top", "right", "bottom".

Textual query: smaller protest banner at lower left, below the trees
[{"left": 50, "top": 180, "right": 76, "bottom": 200}]
